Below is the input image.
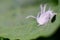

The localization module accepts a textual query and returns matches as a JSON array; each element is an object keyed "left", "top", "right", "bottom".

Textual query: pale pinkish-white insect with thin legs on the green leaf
[{"left": 26, "top": 4, "right": 56, "bottom": 25}]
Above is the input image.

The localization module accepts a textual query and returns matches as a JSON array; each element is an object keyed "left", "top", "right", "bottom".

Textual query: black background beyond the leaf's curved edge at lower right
[{"left": 32, "top": 26, "right": 60, "bottom": 40}]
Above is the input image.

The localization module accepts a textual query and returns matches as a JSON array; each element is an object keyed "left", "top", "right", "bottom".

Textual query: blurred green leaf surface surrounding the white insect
[{"left": 0, "top": 0, "right": 60, "bottom": 40}]
